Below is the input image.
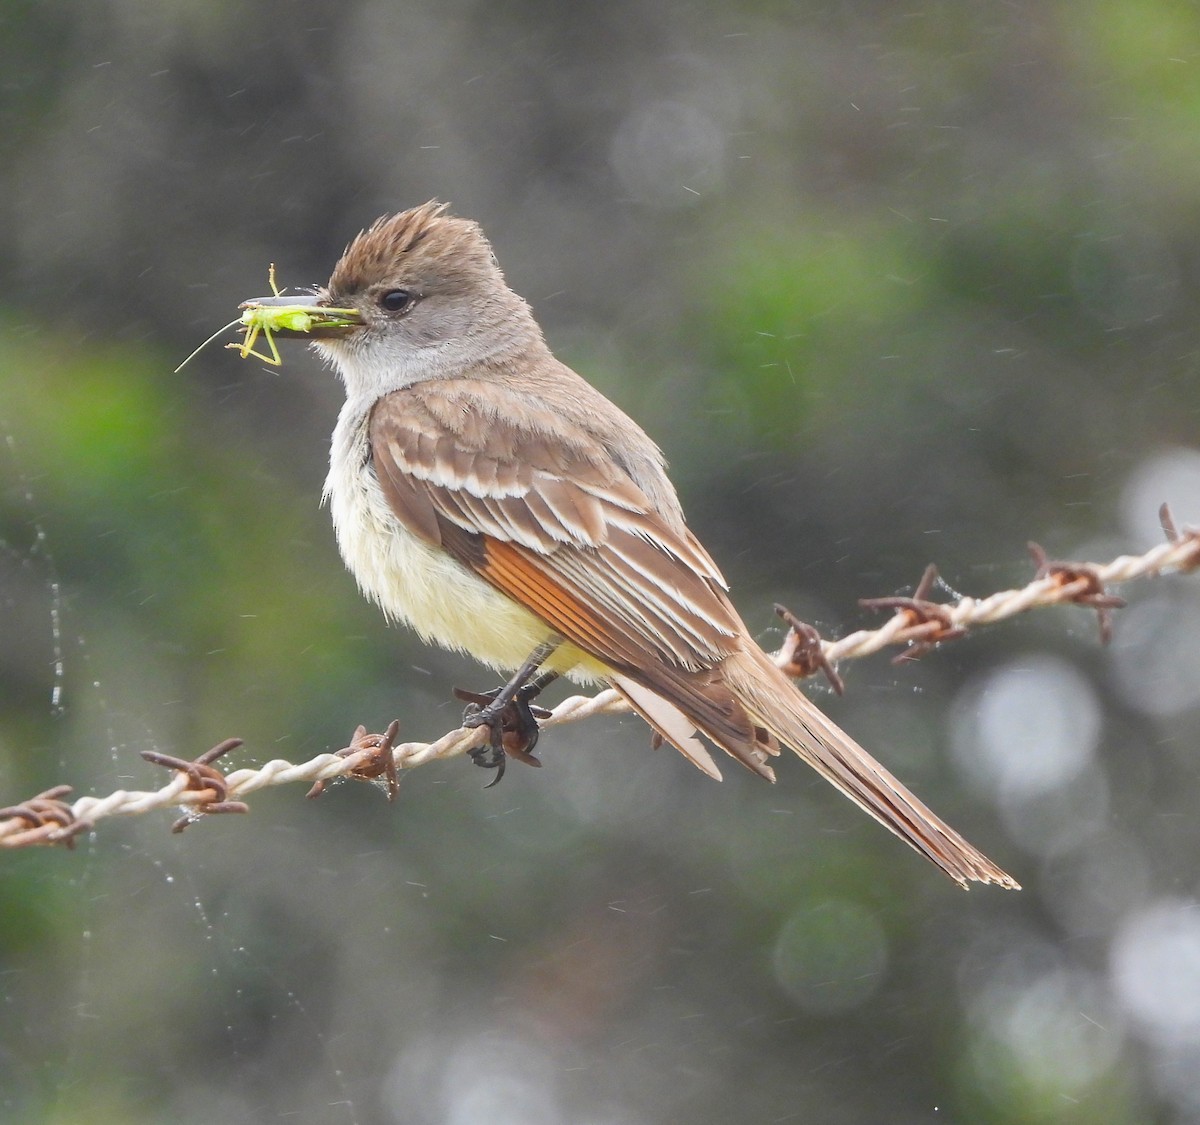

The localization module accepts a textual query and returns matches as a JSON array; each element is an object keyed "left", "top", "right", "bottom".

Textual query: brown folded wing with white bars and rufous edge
[{"left": 370, "top": 379, "right": 775, "bottom": 776}]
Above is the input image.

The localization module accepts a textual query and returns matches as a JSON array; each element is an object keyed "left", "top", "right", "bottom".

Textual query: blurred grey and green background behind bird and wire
[{"left": 0, "top": 0, "right": 1200, "bottom": 1125}]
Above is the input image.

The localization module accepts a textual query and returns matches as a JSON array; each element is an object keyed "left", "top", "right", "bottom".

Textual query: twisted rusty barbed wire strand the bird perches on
[{"left": 0, "top": 504, "right": 1200, "bottom": 848}]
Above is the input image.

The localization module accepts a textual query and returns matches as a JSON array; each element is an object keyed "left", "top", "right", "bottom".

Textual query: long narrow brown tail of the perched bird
[{"left": 715, "top": 643, "right": 1019, "bottom": 890}]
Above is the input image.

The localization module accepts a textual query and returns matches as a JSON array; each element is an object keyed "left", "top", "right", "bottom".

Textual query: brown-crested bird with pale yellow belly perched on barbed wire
[{"left": 248, "top": 201, "right": 1016, "bottom": 888}]
